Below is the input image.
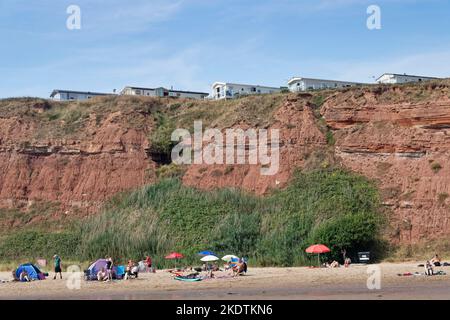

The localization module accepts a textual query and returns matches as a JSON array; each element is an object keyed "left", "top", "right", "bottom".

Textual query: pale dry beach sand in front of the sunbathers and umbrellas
[{"left": 0, "top": 263, "right": 450, "bottom": 300}]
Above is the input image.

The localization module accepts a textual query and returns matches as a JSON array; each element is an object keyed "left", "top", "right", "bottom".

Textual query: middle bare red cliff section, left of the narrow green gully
[{"left": 183, "top": 97, "right": 327, "bottom": 194}]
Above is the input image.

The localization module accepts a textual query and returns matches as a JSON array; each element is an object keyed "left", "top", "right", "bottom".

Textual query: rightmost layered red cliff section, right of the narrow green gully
[{"left": 322, "top": 83, "right": 450, "bottom": 243}]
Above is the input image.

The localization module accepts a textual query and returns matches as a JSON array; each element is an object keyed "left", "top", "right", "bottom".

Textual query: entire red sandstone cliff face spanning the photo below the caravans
[{"left": 0, "top": 81, "right": 450, "bottom": 243}]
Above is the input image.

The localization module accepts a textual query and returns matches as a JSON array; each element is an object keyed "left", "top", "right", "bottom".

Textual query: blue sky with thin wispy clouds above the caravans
[{"left": 0, "top": 0, "right": 450, "bottom": 98}]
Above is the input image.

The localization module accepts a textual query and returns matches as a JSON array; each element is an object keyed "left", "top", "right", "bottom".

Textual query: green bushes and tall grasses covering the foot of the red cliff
[{"left": 0, "top": 169, "right": 383, "bottom": 266}]
